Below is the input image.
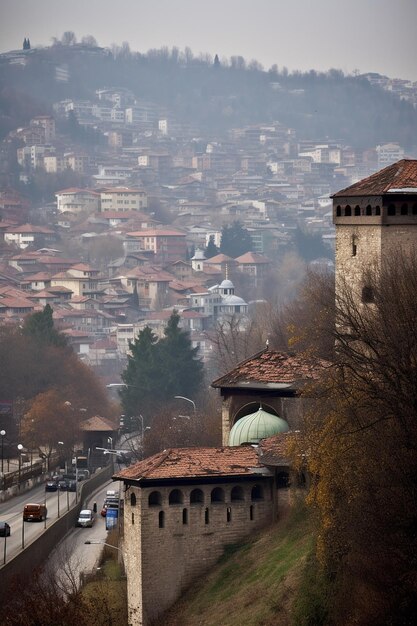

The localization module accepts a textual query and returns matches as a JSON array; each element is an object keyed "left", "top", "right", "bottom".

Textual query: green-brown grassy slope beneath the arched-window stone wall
[{"left": 158, "top": 505, "right": 312, "bottom": 626}]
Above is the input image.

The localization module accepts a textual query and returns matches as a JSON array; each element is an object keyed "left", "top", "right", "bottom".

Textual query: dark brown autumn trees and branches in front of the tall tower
[{"left": 295, "top": 251, "right": 417, "bottom": 626}]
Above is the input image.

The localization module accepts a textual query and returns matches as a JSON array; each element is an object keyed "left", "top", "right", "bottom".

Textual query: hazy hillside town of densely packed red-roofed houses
[{"left": 0, "top": 42, "right": 416, "bottom": 381}]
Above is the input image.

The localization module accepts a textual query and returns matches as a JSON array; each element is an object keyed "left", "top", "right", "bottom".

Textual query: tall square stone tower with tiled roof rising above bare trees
[{"left": 332, "top": 159, "right": 417, "bottom": 302}]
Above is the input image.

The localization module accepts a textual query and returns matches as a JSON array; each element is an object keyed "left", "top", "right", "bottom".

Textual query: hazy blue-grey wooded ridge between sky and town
[{"left": 0, "top": 44, "right": 417, "bottom": 151}]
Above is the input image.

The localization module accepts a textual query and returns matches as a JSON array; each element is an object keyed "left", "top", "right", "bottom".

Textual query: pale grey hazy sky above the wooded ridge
[{"left": 0, "top": 0, "right": 417, "bottom": 81}]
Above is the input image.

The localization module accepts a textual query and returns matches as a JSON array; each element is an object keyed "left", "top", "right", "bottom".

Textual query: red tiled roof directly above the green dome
[{"left": 211, "top": 349, "right": 330, "bottom": 389}]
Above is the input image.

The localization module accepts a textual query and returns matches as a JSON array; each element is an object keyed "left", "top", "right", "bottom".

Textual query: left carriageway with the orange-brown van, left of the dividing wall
[{"left": 0, "top": 484, "right": 75, "bottom": 565}]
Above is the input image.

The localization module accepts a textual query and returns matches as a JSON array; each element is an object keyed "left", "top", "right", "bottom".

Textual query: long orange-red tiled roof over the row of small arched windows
[{"left": 114, "top": 446, "right": 261, "bottom": 480}]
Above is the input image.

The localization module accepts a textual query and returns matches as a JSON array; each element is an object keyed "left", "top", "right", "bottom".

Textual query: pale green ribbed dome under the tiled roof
[{"left": 229, "top": 407, "right": 289, "bottom": 446}]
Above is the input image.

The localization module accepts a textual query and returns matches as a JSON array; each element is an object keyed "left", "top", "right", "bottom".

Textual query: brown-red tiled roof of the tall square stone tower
[{"left": 331, "top": 159, "right": 417, "bottom": 198}]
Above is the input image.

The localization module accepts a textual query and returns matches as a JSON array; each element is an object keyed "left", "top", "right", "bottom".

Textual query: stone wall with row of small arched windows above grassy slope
[{"left": 124, "top": 476, "right": 276, "bottom": 626}]
